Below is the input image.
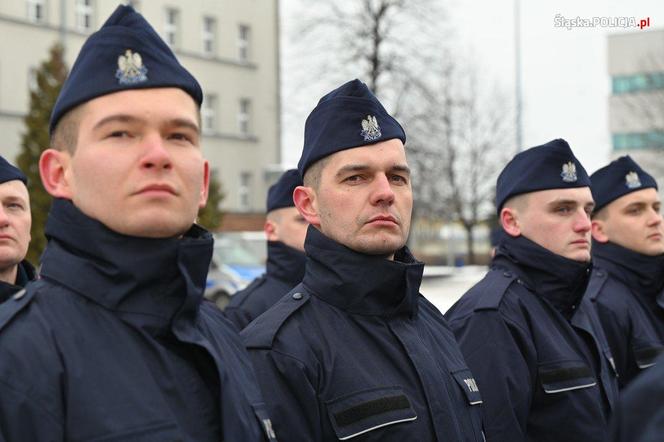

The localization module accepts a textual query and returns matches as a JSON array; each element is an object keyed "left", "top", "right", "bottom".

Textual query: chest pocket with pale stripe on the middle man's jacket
[{"left": 326, "top": 387, "right": 417, "bottom": 440}]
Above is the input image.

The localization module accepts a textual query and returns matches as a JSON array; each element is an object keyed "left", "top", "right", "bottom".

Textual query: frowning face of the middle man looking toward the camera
[{"left": 309, "top": 139, "right": 413, "bottom": 257}]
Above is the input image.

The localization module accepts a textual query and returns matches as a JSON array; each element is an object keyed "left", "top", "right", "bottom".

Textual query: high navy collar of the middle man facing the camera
[{"left": 302, "top": 226, "right": 424, "bottom": 317}]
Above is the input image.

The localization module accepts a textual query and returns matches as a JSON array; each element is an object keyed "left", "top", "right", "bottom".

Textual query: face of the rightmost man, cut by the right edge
[{"left": 593, "top": 188, "right": 664, "bottom": 256}]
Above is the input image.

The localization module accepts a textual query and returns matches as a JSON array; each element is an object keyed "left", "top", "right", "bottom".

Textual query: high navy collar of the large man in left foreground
[{"left": 40, "top": 199, "right": 213, "bottom": 334}]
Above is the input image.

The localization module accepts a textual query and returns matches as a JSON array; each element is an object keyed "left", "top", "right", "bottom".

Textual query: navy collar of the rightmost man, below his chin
[{"left": 593, "top": 241, "right": 664, "bottom": 297}]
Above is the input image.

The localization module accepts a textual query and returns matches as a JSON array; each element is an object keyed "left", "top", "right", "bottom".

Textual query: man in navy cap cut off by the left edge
[{"left": 0, "top": 156, "right": 35, "bottom": 303}]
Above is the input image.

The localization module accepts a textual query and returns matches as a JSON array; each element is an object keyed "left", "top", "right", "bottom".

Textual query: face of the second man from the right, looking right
[{"left": 503, "top": 187, "right": 594, "bottom": 262}]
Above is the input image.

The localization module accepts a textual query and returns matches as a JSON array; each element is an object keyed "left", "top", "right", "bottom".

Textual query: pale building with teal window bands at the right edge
[{"left": 608, "top": 29, "right": 664, "bottom": 185}]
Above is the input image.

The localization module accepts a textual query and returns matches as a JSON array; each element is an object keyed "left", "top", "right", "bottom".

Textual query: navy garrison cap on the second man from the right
[{"left": 496, "top": 138, "right": 590, "bottom": 214}]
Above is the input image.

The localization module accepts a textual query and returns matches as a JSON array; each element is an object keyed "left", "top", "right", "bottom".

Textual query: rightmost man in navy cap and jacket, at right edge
[{"left": 587, "top": 156, "right": 664, "bottom": 387}]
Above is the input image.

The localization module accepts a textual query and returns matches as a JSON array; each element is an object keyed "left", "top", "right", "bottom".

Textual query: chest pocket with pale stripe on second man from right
[{"left": 538, "top": 361, "right": 597, "bottom": 394}]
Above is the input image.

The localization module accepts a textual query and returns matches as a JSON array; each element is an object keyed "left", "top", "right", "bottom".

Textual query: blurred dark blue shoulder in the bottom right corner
[{"left": 611, "top": 357, "right": 664, "bottom": 442}]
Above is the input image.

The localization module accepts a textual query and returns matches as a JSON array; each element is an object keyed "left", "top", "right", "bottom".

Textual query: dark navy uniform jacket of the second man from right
[{"left": 445, "top": 236, "right": 618, "bottom": 442}]
